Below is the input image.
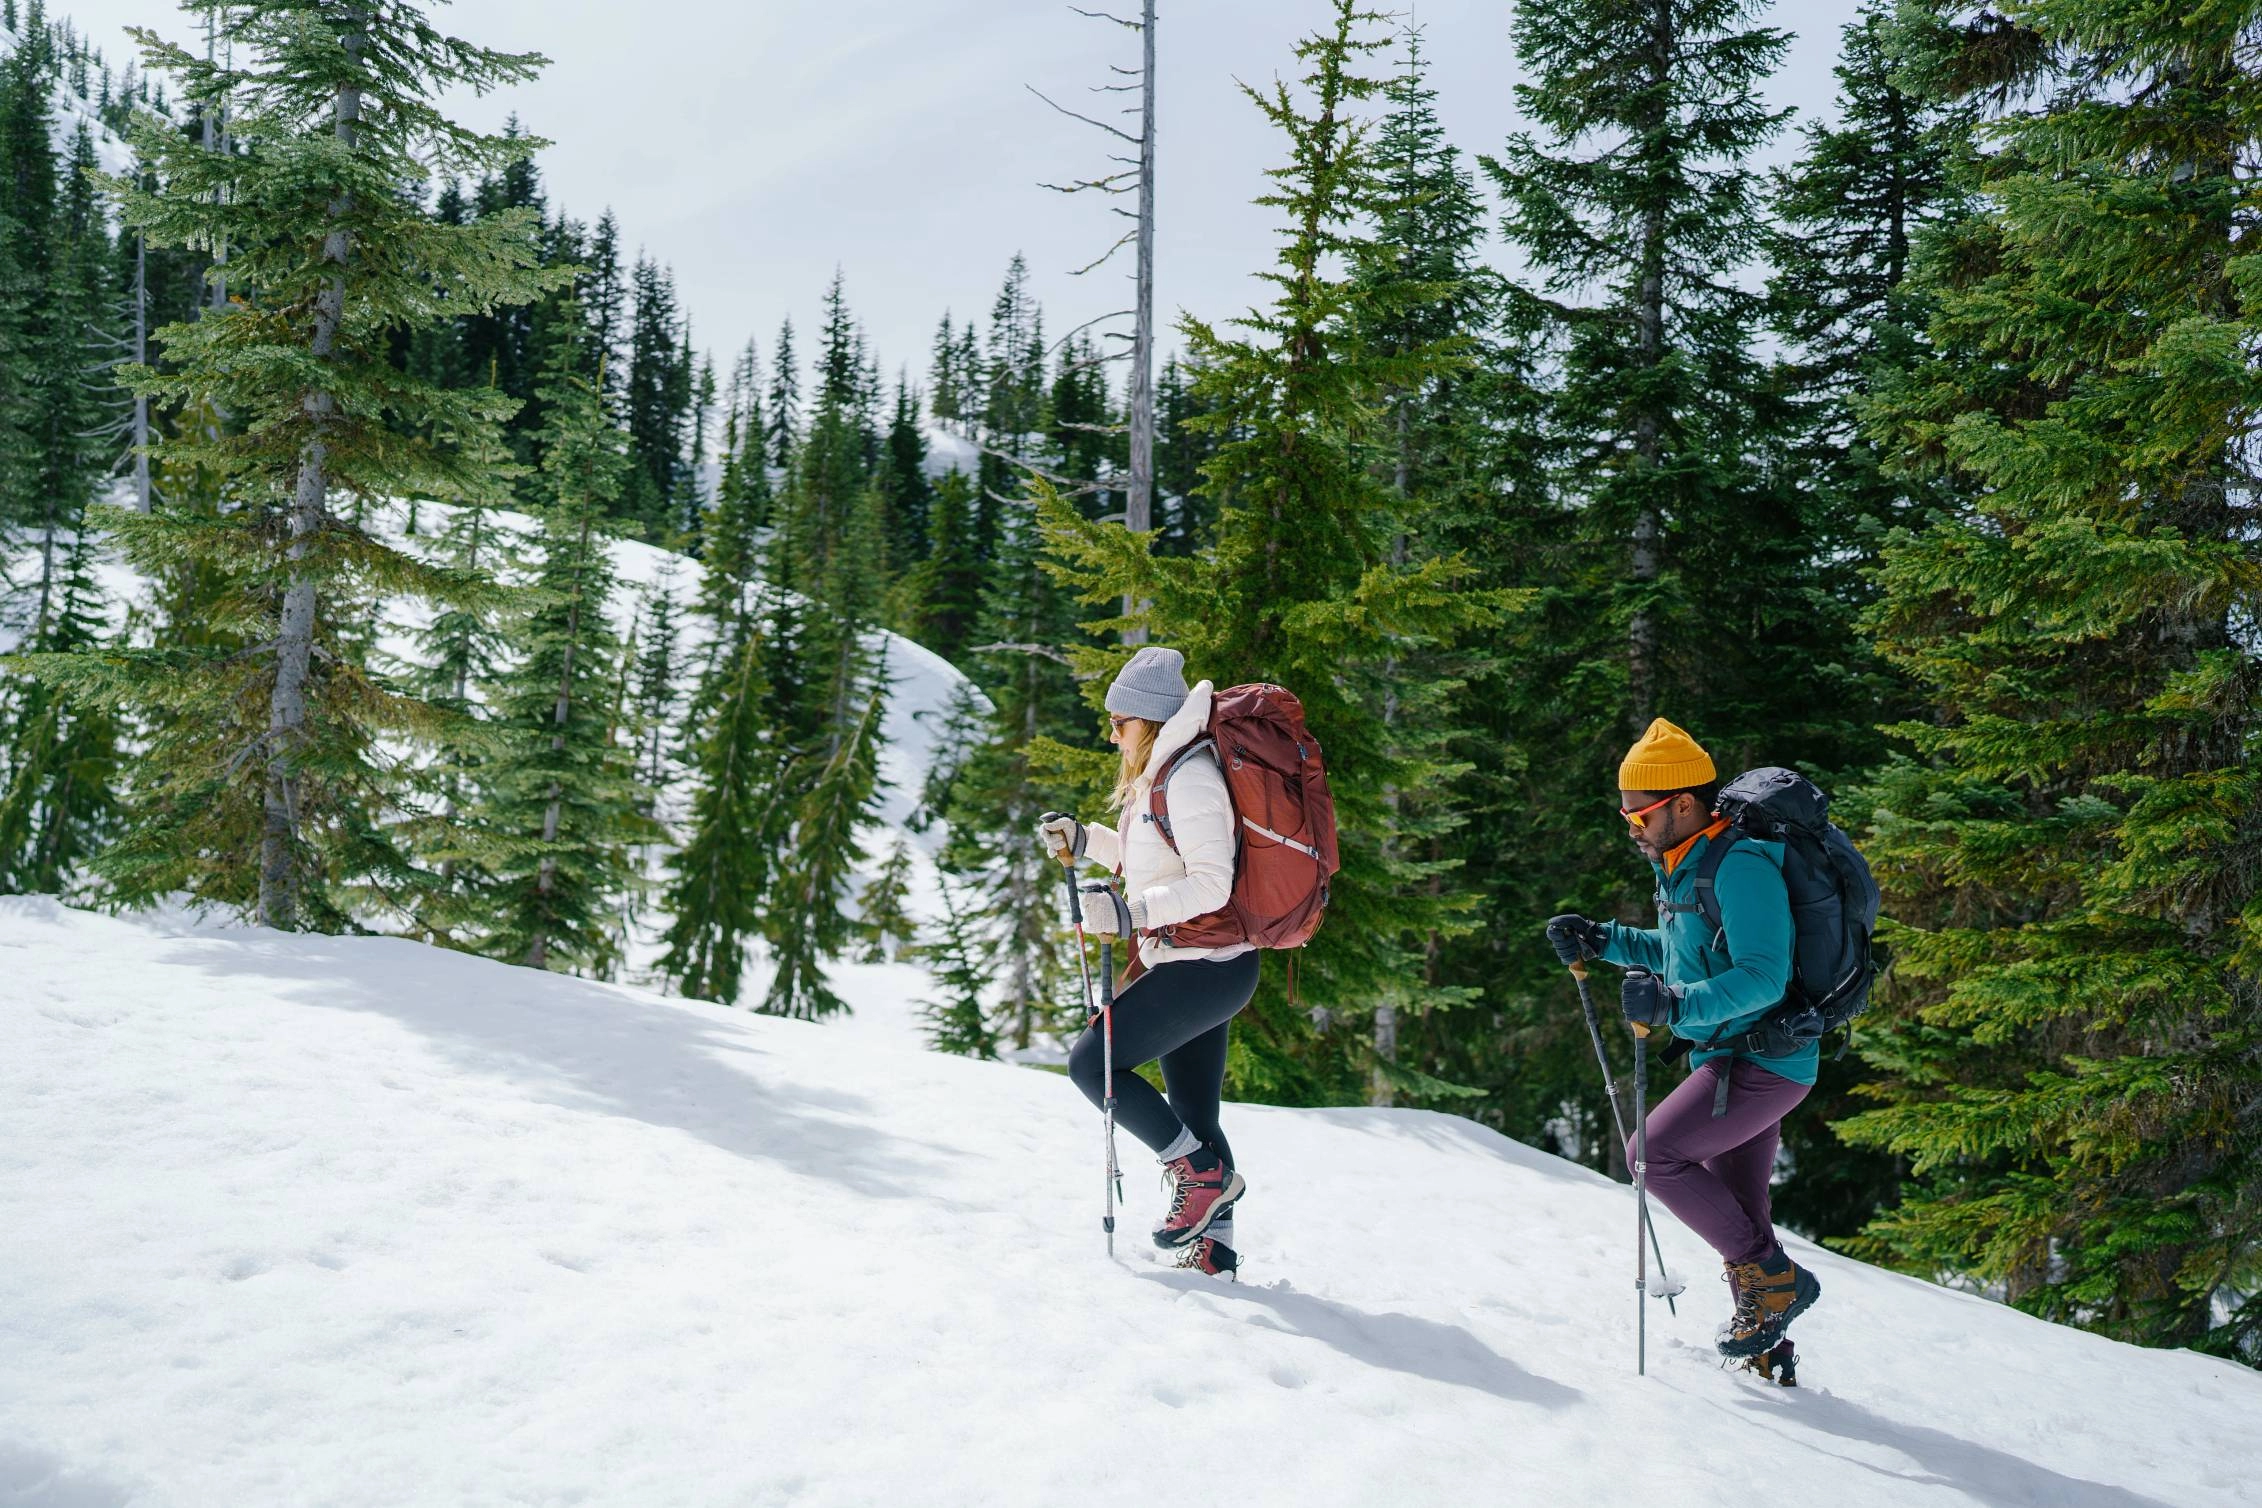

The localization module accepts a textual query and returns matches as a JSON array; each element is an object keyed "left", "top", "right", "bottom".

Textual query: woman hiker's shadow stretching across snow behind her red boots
[{"left": 1140, "top": 1273, "right": 1581, "bottom": 1409}]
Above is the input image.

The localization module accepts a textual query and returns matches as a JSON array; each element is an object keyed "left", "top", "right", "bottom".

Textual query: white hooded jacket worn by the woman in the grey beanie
[{"left": 1083, "top": 681, "right": 1249, "bottom": 968}]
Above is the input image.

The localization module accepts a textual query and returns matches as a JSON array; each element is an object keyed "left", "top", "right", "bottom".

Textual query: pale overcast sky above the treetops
[{"left": 50, "top": 0, "right": 1855, "bottom": 395}]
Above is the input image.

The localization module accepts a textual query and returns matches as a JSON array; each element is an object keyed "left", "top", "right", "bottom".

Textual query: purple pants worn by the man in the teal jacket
[{"left": 1626, "top": 1058, "right": 1812, "bottom": 1262}]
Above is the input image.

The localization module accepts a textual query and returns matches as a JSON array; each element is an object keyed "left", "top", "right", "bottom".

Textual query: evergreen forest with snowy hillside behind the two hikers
[{"left": 0, "top": 0, "right": 2262, "bottom": 1366}]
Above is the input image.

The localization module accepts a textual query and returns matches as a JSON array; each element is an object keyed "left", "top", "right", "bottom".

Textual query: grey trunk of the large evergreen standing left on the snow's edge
[{"left": 260, "top": 7, "right": 369, "bottom": 931}]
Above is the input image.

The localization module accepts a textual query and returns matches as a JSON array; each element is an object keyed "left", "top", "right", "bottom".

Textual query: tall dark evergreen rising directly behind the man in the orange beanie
[{"left": 1461, "top": 0, "right": 1882, "bottom": 1169}]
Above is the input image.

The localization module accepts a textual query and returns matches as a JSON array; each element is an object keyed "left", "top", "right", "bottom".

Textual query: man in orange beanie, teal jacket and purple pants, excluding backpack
[{"left": 1547, "top": 717, "right": 1821, "bottom": 1357}]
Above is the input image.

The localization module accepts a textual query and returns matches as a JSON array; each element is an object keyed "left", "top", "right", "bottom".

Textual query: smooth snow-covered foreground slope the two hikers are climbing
[{"left": 0, "top": 900, "right": 2262, "bottom": 1508}]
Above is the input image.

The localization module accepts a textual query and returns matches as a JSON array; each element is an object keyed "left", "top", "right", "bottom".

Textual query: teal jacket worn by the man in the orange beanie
[{"left": 1601, "top": 834, "right": 1821, "bottom": 1083}]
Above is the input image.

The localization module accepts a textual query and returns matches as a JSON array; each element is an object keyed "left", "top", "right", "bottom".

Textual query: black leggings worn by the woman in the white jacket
[{"left": 1068, "top": 950, "right": 1258, "bottom": 1167}]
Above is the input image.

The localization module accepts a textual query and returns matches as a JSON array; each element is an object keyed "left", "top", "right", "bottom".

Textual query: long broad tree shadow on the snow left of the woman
[{"left": 167, "top": 936, "right": 950, "bottom": 1207}]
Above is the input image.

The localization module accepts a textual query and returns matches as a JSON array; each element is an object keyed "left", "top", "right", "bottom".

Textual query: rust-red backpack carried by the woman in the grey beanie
[{"left": 1147, "top": 683, "right": 1341, "bottom": 947}]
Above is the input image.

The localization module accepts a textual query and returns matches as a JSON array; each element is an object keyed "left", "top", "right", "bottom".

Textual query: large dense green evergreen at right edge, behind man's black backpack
[{"left": 1841, "top": 0, "right": 2262, "bottom": 1363}]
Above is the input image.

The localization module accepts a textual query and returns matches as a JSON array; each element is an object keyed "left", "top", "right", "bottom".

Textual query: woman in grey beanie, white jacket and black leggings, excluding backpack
[{"left": 1038, "top": 644, "right": 1258, "bottom": 1275}]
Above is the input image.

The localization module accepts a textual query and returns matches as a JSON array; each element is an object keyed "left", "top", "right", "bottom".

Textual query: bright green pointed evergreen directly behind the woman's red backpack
[{"left": 1045, "top": 0, "right": 1504, "bottom": 1103}]
